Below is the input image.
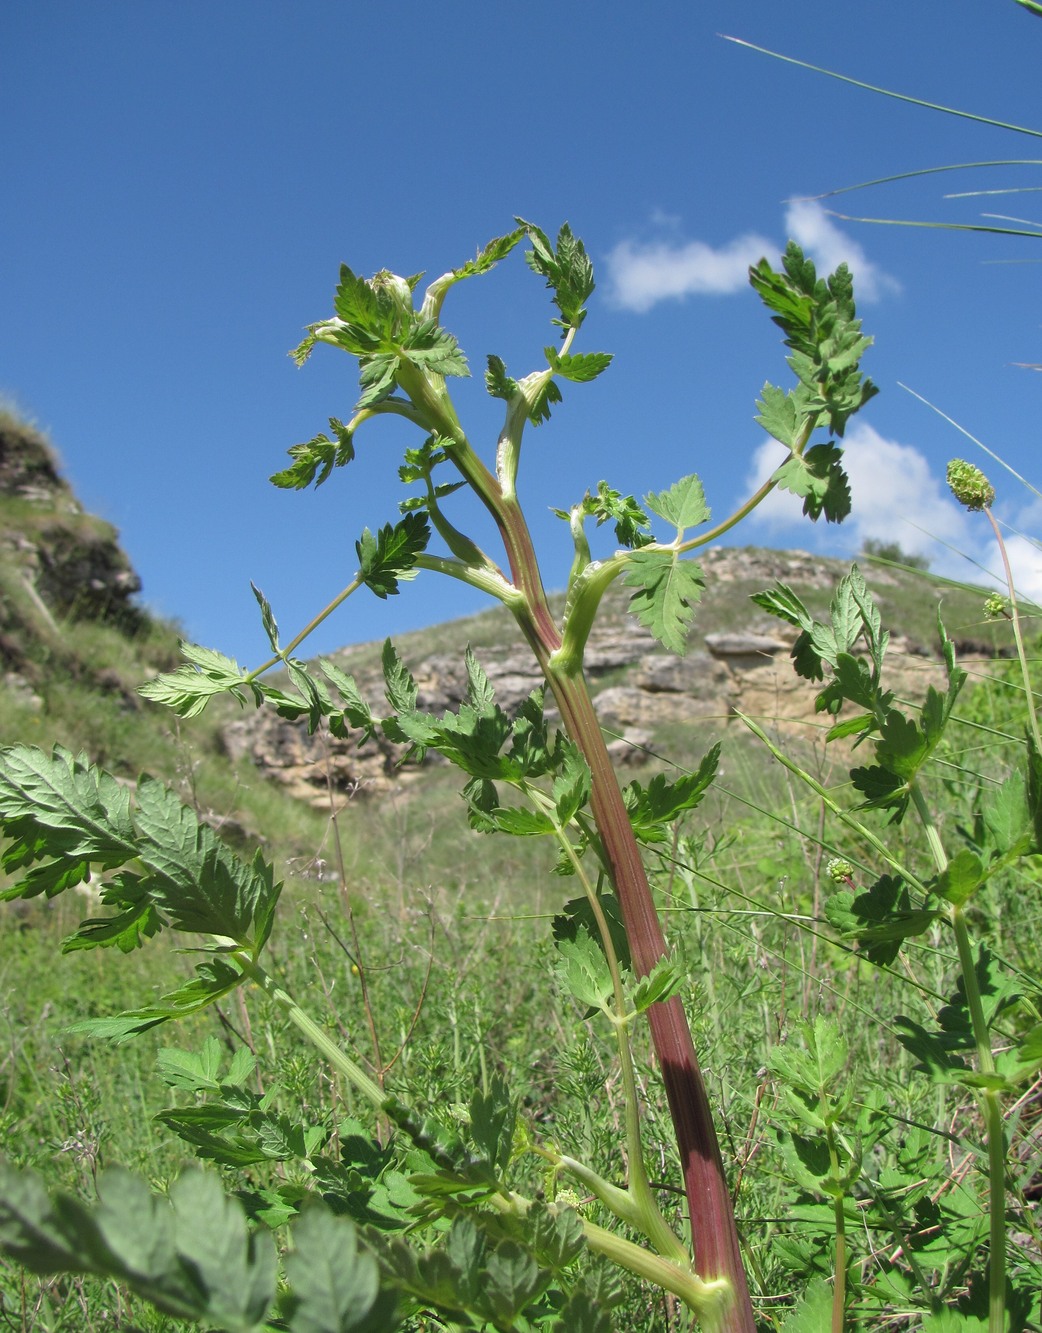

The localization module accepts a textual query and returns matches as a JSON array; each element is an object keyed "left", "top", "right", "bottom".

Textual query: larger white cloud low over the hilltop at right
[{"left": 746, "top": 423, "right": 1042, "bottom": 604}]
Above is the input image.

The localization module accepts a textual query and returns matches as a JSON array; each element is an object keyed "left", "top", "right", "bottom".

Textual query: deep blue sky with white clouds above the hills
[{"left": 0, "top": 0, "right": 1042, "bottom": 664}]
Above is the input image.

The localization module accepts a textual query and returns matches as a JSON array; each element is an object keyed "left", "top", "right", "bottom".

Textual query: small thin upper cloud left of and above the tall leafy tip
[{"left": 608, "top": 200, "right": 899, "bottom": 313}]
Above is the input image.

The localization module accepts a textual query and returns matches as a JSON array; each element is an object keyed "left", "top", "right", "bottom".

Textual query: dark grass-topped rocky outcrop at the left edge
[{"left": 0, "top": 412, "right": 143, "bottom": 653}]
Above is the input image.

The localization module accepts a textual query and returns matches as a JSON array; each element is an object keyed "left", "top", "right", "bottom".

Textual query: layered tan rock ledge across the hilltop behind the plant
[{"left": 221, "top": 549, "right": 964, "bottom": 808}]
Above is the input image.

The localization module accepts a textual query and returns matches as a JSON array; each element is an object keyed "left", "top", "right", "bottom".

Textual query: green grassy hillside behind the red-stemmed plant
[{"left": 0, "top": 410, "right": 1042, "bottom": 1333}]
